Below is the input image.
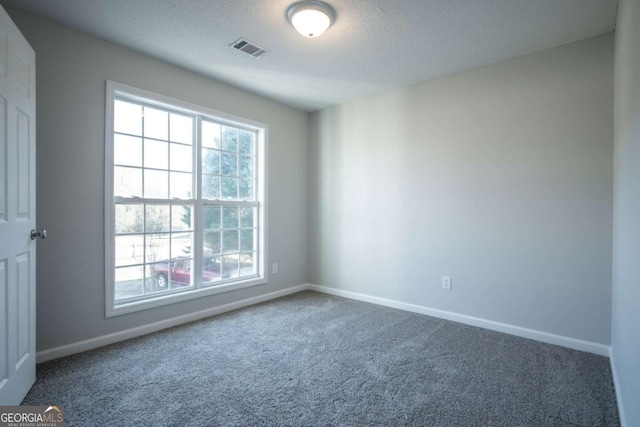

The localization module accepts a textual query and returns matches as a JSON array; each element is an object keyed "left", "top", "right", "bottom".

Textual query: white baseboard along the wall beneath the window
[{"left": 36, "top": 284, "right": 309, "bottom": 363}]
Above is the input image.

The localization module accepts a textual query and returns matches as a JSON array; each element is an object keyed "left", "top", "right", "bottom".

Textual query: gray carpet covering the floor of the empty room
[{"left": 23, "top": 292, "right": 619, "bottom": 426}]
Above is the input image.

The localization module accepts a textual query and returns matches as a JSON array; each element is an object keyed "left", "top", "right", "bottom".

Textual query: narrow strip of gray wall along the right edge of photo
[{"left": 611, "top": 0, "right": 640, "bottom": 426}]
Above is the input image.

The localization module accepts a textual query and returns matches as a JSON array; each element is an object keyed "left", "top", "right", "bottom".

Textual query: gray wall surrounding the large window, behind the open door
[{"left": 8, "top": 9, "right": 309, "bottom": 351}]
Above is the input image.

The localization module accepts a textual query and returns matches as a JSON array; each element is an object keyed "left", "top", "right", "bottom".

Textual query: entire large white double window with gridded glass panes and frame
[{"left": 105, "top": 82, "right": 267, "bottom": 316}]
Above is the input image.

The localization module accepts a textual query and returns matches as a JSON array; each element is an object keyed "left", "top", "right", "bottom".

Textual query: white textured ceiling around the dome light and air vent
[{"left": 0, "top": 0, "right": 617, "bottom": 111}]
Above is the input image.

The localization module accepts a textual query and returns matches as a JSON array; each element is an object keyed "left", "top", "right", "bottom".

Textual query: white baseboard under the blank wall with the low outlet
[{"left": 309, "top": 285, "right": 610, "bottom": 356}]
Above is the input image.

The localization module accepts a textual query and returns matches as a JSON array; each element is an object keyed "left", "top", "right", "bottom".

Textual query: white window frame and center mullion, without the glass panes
[{"left": 104, "top": 80, "right": 268, "bottom": 318}]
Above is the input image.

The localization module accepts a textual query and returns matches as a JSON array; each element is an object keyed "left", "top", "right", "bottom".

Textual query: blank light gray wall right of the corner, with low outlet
[{"left": 310, "top": 35, "right": 613, "bottom": 344}]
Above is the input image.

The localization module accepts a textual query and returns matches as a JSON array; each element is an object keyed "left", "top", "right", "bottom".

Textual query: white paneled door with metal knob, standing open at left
[{"left": 0, "top": 7, "right": 36, "bottom": 405}]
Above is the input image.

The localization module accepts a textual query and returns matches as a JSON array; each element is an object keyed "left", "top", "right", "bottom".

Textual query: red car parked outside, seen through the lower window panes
[{"left": 152, "top": 257, "right": 220, "bottom": 290}]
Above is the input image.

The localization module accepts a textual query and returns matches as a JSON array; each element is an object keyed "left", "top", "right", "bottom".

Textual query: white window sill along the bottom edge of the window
[{"left": 106, "top": 277, "right": 267, "bottom": 318}]
